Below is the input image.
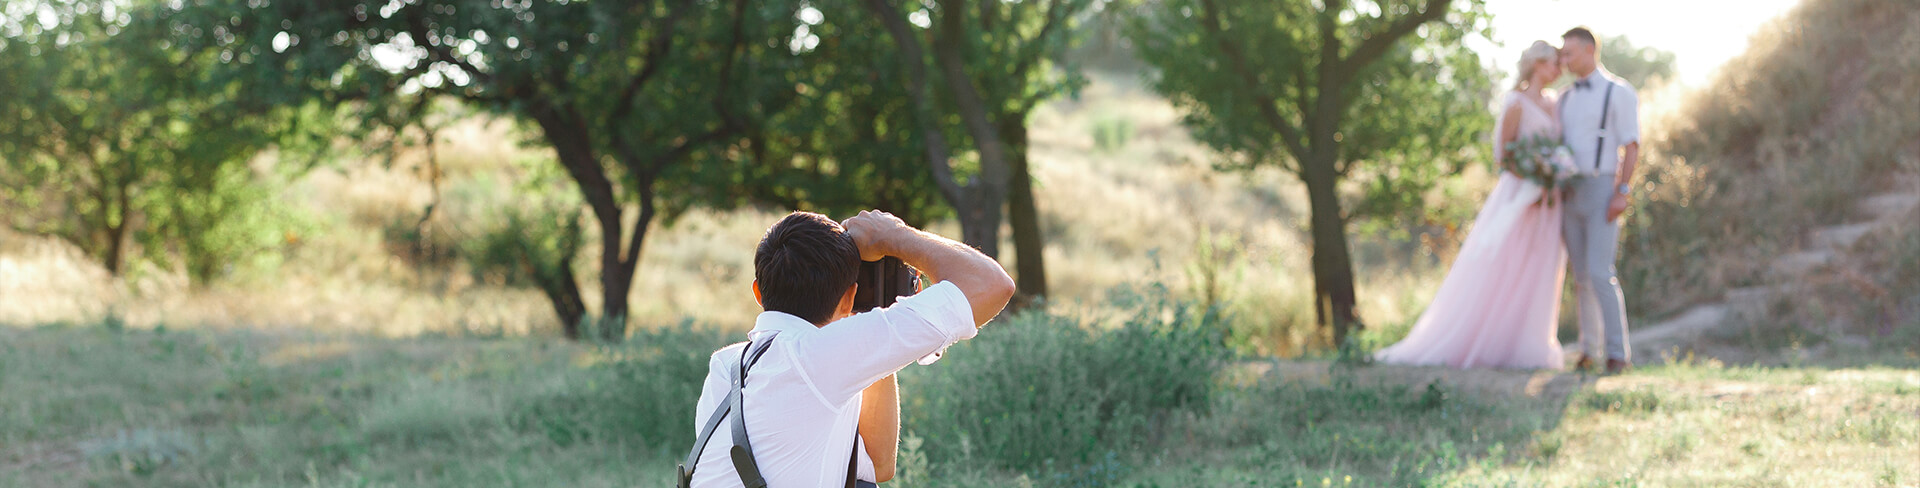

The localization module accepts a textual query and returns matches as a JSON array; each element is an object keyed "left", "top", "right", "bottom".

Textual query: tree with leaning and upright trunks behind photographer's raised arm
[{"left": 864, "top": 0, "right": 1092, "bottom": 305}]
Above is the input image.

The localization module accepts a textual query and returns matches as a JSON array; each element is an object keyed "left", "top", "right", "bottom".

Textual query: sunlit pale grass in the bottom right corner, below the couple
[{"left": 1442, "top": 365, "right": 1920, "bottom": 488}]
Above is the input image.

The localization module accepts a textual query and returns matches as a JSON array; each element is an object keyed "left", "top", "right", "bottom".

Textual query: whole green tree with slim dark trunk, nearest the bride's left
[{"left": 1131, "top": 0, "right": 1492, "bottom": 344}]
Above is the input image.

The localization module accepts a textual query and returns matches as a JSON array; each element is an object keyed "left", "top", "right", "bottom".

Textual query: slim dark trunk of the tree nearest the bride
[{"left": 1300, "top": 154, "right": 1363, "bottom": 348}]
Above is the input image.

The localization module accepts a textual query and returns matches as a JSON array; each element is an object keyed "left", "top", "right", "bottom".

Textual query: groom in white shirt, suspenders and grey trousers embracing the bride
[{"left": 1559, "top": 27, "right": 1640, "bottom": 375}]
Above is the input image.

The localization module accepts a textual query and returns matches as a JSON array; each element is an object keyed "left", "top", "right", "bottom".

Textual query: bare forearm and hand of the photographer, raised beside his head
[{"left": 843, "top": 209, "right": 1014, "bottom": 327}]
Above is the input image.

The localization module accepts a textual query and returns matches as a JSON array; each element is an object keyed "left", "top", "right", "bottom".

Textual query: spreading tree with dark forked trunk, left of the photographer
[{"left": 175, "top": 0, "right": 795, "bottom": 340}]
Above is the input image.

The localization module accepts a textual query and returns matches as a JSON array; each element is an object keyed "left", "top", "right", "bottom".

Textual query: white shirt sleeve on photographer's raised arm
[{"left": 789, "top": 281, "right": 979, "bottom": 409}]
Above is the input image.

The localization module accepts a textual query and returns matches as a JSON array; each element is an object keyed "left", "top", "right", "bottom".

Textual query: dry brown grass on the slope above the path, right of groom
[{"left": 1620, "top": 0, "right": 1920, "bottom": 317}]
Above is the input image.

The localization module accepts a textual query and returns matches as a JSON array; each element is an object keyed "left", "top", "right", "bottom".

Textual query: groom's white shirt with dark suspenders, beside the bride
[{"left": 1561, "top": 67, "right": 1640, "bottom": 175}]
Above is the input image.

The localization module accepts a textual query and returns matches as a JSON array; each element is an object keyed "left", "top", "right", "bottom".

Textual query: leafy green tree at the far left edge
[{"left": 0, "top": 0, "right": 296, "bottom": 282}]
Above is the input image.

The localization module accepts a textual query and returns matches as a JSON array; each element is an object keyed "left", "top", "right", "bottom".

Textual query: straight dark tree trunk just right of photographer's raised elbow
[{"left": 1000, "top": 121, "right": 1046, "bottom": 309}]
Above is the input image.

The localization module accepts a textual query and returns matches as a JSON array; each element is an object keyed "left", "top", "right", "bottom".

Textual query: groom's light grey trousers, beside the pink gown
[{"left": 1561, "top": 173, "right": 1632, "bottom": 361}]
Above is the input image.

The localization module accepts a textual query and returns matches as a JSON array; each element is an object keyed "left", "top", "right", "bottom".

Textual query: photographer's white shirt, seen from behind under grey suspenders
[{"left": 693, "top": 282, "right": 977, "bottom": 488}]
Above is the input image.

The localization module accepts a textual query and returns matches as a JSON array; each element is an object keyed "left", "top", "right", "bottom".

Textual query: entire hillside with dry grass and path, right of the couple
[{"left": 1620, "top": 0, "right": 1920, "bottom": 363}]
